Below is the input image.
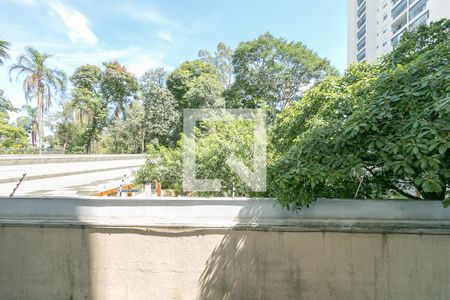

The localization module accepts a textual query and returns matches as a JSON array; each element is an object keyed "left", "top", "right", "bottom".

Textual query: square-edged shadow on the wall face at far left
[{"left": 0, "top": 225, "right": 91, "bottom": 300}]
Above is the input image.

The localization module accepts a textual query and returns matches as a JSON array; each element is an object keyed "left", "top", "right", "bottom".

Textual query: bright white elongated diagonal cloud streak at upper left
[{"left": 49, "top": 1, "right": 98, "bottom": 46}]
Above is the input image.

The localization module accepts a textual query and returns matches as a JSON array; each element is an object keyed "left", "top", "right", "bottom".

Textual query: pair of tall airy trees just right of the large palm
[{"left": 56, "top": 62, "right": 137, "bottom": 153}]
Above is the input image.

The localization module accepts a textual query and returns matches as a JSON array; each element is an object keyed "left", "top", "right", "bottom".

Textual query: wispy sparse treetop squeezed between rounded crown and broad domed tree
[{"left": 198, "top": 42, "right": 233, "bottom": 89}]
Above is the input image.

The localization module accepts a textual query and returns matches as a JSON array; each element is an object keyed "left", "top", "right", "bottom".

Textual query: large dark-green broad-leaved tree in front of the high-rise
[{"left": 270, "top": 22, "right": 450, "bottom": 208}]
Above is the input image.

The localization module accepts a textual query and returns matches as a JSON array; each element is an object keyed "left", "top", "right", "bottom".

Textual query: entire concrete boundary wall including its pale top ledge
[{"left": 0, "top": 198, "right": 450, "bottom": 299}]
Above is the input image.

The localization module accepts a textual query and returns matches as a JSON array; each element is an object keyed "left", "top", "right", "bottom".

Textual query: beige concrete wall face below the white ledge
[{"left": 0, "top": 227, "right": 450, "bottom": 300}]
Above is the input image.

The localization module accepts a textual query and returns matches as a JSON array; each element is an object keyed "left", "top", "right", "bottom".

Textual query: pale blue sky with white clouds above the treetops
[{"left": 0, "top": 0, "right": 346, "bottom": 116}]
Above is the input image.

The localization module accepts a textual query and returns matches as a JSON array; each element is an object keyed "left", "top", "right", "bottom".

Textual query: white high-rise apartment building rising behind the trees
[{"left": 347, "top": 0, "right": 450, "bottom": 64}]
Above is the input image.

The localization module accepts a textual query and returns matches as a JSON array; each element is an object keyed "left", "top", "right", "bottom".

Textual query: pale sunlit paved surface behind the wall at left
[{"left": 0, "top": 155, "right": 145, "bottom": 196}]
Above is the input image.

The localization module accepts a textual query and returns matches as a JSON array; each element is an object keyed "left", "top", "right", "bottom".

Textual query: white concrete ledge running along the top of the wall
[{"left": 0, "top": 197, "right": 450, "bottom": 234}]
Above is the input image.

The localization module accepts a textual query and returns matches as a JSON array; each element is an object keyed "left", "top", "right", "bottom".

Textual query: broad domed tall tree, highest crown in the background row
[{"left": 227, "top": 33, "right": 336, "bottom": 115}]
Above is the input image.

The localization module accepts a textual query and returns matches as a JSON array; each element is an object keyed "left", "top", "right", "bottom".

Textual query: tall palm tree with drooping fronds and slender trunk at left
[{"left": 9, "top": 47, "right": 67, "bottom": 150}]
